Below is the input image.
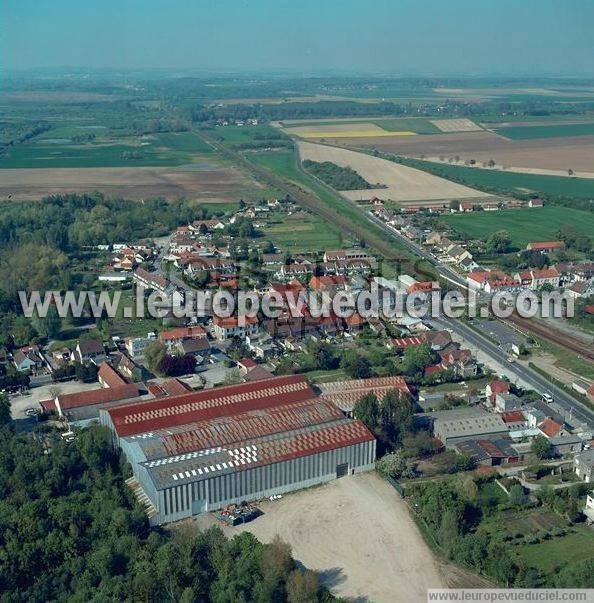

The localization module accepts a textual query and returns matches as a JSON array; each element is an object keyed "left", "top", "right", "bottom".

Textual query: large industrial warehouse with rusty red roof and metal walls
[{"left": 100, "top": 375, "right": 375, "bottom": 525}]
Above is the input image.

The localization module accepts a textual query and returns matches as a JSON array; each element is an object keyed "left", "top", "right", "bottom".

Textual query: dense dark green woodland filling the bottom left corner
[{"left": 0, "top": 422, "right": 332, "bottom": 602}]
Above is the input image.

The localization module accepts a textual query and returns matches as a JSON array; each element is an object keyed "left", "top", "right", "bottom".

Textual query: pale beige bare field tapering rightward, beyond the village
[{"left": 298, "top": 137, "right": 489, "bottom": 204}]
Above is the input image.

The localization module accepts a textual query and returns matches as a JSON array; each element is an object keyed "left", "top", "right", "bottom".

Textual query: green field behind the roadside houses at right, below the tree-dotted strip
[{"left": 439, "top": 205, "right": 594, "bottom": 248}]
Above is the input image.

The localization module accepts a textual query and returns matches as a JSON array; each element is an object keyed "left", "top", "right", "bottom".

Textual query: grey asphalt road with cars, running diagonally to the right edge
[{"left": 432, "top": 317, "right": 594, "bottom": 428}]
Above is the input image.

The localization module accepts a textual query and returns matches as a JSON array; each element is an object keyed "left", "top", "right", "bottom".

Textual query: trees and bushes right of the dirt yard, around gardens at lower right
[{"left": 411, "top": 475, "right": 594, "bottom": 588}]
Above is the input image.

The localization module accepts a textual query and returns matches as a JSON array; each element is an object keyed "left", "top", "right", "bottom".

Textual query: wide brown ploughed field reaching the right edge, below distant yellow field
[{"left": 326, "top": 131, "right": 594, "bottom": 175}]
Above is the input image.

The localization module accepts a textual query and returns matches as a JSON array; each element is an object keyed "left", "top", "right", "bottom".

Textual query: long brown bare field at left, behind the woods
[{"left": 0, "top": 163, "right": 260, "bottom": 203}]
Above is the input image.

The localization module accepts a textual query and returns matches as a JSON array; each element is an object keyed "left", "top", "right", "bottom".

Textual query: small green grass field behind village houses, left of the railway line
[{"left": 263, "top": 212, "right": 346, "bottom": 252}]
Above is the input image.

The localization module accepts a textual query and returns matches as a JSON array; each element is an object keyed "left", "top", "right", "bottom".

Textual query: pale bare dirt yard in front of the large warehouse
[{"left": 199, "top": 472, "right": 447, "bottom": 602}]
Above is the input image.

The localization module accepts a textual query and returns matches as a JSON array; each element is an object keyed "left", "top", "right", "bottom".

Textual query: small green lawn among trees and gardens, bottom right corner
[{"left": 516, "top": 525, "right": 594, "bottom": 573}]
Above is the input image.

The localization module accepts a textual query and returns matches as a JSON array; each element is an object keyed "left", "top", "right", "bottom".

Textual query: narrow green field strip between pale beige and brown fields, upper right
[{"left": 402, "top": 158, "right": 594, "bottom": 199}]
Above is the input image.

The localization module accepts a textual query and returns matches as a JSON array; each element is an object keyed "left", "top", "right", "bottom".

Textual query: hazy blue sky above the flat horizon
[{"left": 0, "top": 0, "right": 594, "bottom": 76}]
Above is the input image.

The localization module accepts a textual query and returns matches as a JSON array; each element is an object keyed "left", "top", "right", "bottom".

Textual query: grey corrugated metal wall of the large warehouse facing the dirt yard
[{"left": 150, "top": 441, "right": 375, "bottom": 524}]
